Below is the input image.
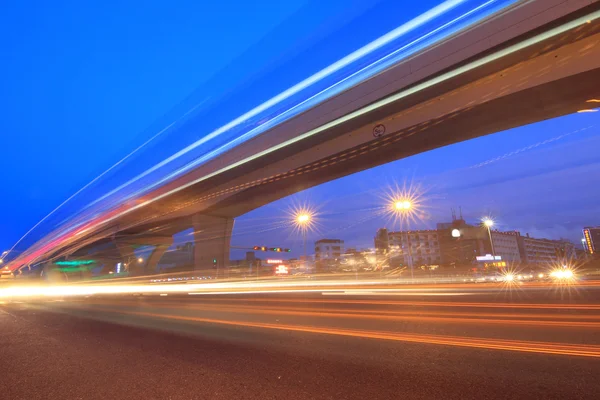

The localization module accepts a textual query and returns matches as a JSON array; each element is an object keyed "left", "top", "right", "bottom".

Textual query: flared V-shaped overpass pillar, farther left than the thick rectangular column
[{"left": 115, "top": 235, "right": 173, "bottom": 275}]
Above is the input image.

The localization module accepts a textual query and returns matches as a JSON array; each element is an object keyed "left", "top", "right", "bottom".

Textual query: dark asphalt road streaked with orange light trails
[{"left": 0, "top": 286, "right": 600, "bottom": 399}]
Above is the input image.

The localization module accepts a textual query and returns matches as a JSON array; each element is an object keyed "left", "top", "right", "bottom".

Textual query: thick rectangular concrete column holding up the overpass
[{"left": 192, "top": 214, "right": 234, "bottom": 276}]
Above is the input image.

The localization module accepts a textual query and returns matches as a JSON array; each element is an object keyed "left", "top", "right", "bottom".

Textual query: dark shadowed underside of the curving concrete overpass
[{"left": 207, "top": 68, "right": 600, "bottom": 216}]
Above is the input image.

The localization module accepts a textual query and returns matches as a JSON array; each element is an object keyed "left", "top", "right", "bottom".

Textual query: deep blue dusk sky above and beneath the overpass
[{"left": 0, "top": 0, "right": 600, "bottom": 260}]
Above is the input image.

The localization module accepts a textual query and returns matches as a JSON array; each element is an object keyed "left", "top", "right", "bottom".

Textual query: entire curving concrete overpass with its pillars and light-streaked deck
[{"left": 12, "top": 0, "right": 600, "bottom": 272}]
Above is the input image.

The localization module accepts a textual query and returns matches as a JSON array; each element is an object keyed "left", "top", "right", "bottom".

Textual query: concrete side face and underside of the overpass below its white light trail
[{"left": 124, "top": 20, "right": 600, "bottom": 223}]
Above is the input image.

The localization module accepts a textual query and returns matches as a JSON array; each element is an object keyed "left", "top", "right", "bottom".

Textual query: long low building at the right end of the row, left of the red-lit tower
[{"left": 519, "top": 234, "right": 576, "bottom": 266}]
